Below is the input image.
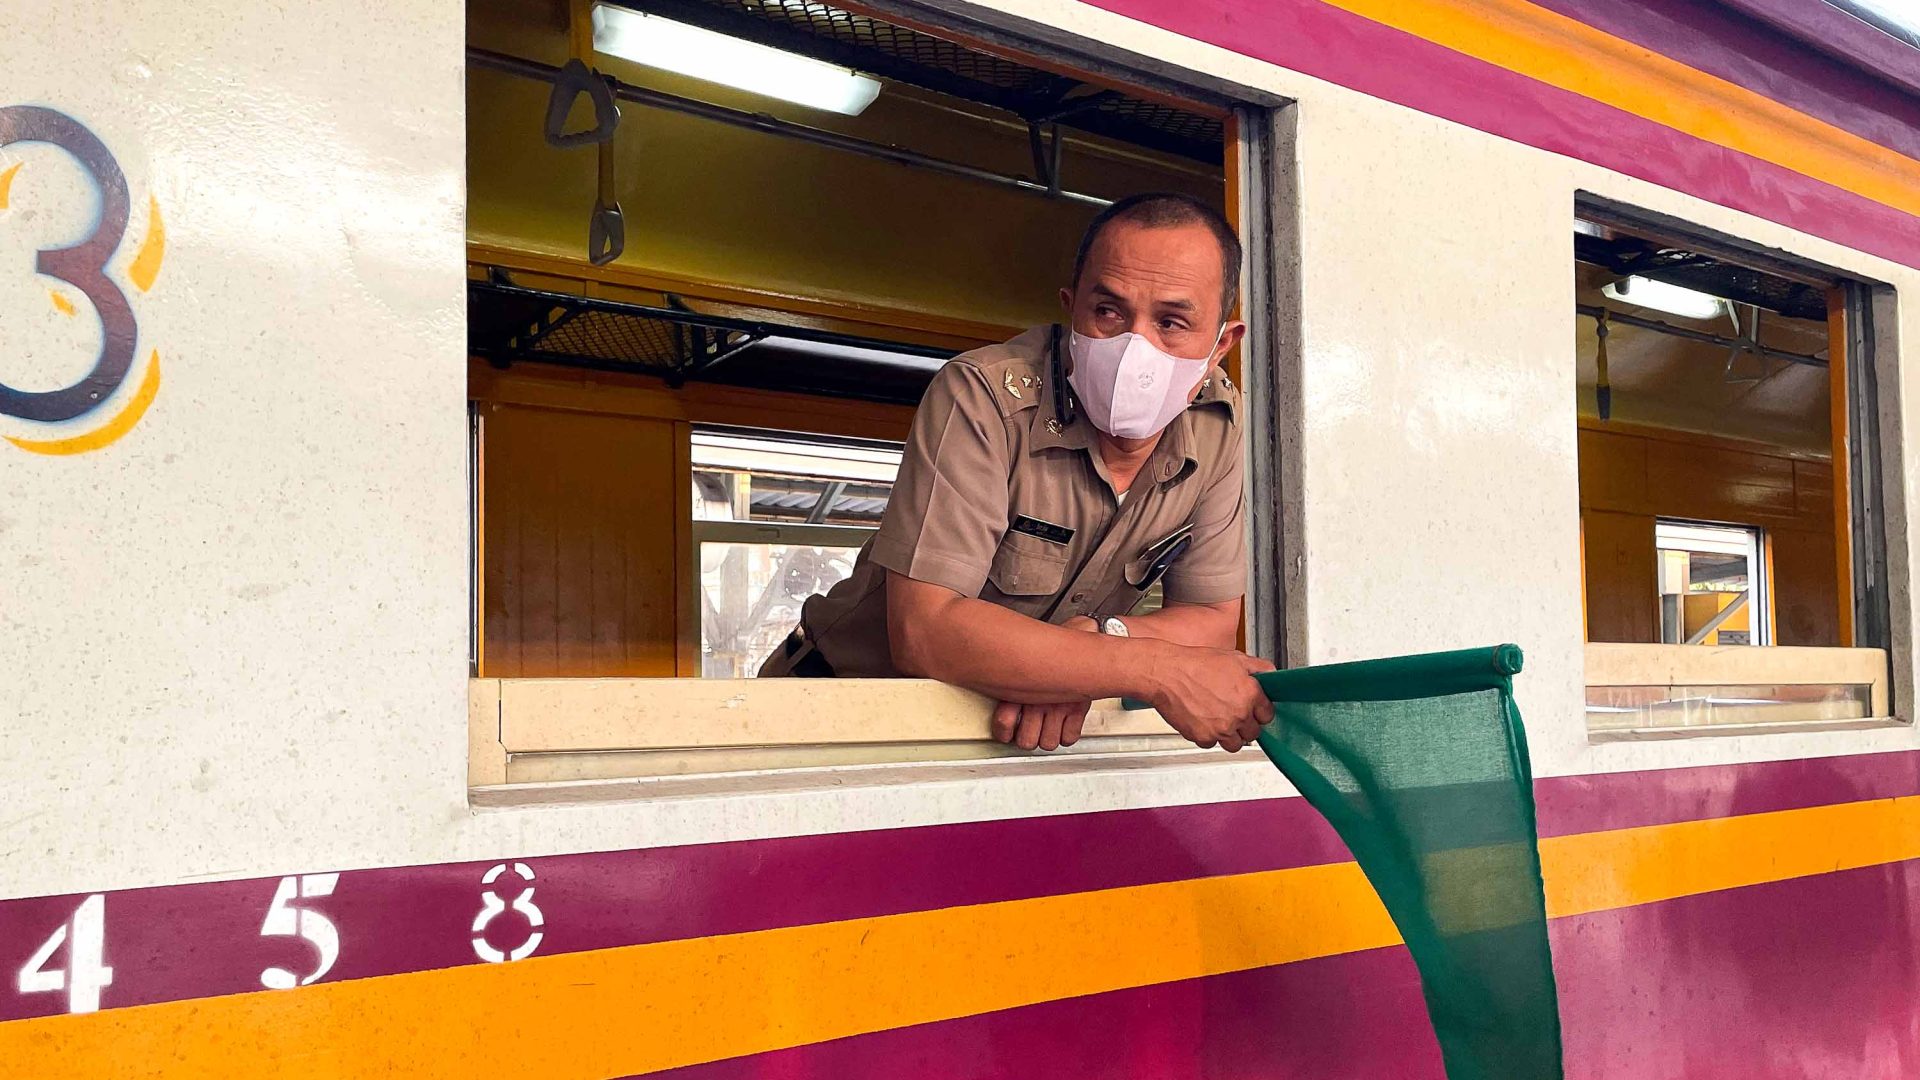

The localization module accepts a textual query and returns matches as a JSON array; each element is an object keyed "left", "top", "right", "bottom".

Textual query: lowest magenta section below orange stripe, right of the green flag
[{"left": 1553, "top": 861, "right": 1920, "bottom": 1080}]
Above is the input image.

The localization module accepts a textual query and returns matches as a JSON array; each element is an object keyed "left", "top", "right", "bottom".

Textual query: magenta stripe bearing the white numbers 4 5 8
[{"left": 0, "top": 751, "right": 1920, "bottom": 1020}]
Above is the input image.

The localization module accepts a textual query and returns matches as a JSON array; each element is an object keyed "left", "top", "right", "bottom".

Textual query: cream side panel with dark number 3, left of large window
[{"left": 0, "top": 0, "right": 467, "bottom": 896}]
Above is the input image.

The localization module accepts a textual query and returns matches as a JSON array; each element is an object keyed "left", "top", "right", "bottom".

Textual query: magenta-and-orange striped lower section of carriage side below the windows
[{"left": 0, "top": 753, "right": 1920, "bottom": 1076}]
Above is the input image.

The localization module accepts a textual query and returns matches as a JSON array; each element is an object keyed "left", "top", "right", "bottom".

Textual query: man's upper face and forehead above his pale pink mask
[{"left": 1060, "top": 221, "right": 1246, "bottom": 365}]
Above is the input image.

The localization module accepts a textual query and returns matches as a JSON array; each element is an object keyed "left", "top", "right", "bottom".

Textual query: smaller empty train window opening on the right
[{"left": 1574, "top": 200, "right": 1891, "bottom": 740}]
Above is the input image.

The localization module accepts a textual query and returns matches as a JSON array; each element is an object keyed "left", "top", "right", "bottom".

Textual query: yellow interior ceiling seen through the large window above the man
[{"left": 467, "top": 0, "right": 1225, "bottom": 329}]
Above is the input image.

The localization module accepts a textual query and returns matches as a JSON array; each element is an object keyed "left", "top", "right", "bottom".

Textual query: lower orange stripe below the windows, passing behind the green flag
[{"left": 0, "top": 796, "right": 1920, "bottom": 1078}]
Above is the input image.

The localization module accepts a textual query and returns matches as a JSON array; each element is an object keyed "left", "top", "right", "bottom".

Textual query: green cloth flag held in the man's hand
[{"left": 1260, "top": 646, "right": 1561, "bottom": 1080}]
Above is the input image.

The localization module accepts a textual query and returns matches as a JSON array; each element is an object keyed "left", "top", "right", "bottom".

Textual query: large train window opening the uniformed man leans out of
[{"left": 468, "top": 0, "right": 1277, "bottom": 784}]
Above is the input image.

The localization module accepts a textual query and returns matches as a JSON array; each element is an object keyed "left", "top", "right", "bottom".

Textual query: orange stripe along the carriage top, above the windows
[{"left": 1327, "top": 0, "right": 1920, "bottom": 213}]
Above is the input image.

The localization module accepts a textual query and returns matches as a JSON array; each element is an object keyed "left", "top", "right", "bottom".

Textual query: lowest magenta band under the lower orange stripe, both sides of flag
[{"left": 633, "top": 863, "right": 1920, "bottom": 1080}]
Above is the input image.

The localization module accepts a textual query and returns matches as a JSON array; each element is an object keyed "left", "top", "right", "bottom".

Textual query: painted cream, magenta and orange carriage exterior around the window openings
[{"left": 0, "top": 0, "right": 1920, "bottom": 1076}]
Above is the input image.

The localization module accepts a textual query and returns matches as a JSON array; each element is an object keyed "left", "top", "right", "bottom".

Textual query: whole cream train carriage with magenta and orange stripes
[{"left": 0, "top": 0, "right": 1920, "bottom": 1080}]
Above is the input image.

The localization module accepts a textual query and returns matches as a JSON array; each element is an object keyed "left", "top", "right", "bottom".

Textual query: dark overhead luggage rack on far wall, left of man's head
[{"left": 467, "top": 271, "right": 954, "bottom": 404}]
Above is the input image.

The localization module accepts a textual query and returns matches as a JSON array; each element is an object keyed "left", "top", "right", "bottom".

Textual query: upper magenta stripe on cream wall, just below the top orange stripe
[{"left": 1096, "top": 0, "right": 1920, "bottom": 267}]
